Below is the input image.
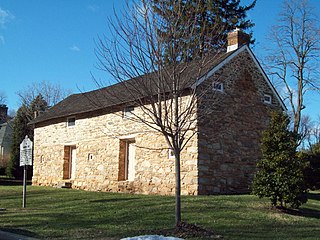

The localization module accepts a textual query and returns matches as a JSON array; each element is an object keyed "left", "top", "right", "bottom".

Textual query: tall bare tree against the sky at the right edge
[{"left": 267, "top": 0, "right": 320, "bottom": 133}]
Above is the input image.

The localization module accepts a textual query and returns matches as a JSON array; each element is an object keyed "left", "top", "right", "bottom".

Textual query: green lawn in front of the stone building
[{"left": 0, "top": 186, "right": 320, "bottom": 240}]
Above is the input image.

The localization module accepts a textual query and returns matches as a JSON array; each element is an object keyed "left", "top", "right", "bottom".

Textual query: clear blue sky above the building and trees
[{"left": 0, "top": 0, "right": 320, "bottom": 118}]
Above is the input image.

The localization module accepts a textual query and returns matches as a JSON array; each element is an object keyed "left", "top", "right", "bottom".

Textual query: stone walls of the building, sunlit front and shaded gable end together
[{"left": 33, "top": 47, "right": 281, "bottom": 195}]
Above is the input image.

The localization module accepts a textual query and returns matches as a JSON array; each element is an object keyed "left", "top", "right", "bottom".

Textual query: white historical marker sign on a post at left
[{"left": 20, "top": 136, "right": 32, "bottom": 208}]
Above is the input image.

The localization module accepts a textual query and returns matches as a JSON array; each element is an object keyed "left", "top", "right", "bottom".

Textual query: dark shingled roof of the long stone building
[{"left": 29, "top": 52, "right": 233, "bottom": 124}]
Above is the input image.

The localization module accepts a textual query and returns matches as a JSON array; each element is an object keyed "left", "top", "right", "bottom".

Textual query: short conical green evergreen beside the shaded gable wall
[{"left": 252, "top": 112, "right": 307, "bottom": 208}]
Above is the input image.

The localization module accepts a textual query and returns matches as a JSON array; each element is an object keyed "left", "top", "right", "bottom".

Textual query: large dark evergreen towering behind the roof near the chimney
[{"left": 151, "top": 0, "right": 256, "bottom": 63}]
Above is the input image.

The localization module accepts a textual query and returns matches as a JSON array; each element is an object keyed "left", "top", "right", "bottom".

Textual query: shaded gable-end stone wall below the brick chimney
[{"left": 198, "top": 51, "right": 281, "bottom": 194}]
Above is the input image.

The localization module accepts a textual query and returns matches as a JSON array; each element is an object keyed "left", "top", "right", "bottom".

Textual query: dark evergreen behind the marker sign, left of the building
[{"left": 6, "top": 95, "right": 48, "bottom": 179}]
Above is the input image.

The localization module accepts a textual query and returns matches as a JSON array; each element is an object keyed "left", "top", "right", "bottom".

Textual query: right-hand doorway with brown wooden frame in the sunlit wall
[{"left": 118, "top": 139, "right": 136, "bottom": 181}]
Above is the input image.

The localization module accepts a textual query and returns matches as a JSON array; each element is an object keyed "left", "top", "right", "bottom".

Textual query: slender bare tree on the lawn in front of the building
[{"left": 96, "top": 0, "right": 228, "bottom": 225}]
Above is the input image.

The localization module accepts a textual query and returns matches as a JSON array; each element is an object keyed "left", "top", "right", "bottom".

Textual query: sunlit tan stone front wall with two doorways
[{"left": 32, "top": 98, "right": 198, "bottom": 195}]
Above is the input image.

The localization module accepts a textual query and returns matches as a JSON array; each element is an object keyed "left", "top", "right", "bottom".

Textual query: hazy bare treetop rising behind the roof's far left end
[{"left": 17, "top": 81, "right": 70, "bottom": 106}]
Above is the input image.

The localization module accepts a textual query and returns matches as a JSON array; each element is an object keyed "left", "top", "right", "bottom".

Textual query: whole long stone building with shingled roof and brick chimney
[{"left": 31, "top": 31, "right": 285, "bottom": 195}]
